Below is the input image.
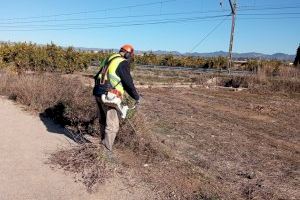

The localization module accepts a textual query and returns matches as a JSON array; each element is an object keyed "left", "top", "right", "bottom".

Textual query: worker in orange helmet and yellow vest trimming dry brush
[{"left": 93, "top": 44, "right": 140, "bottom": 151}]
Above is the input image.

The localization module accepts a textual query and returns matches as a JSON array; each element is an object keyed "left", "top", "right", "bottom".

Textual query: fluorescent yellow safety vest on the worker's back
[{"left": 98, "top": 54, "right": 125, "bottom": 95}]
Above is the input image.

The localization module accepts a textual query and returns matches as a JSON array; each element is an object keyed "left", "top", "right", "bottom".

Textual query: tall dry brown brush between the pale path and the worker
[{"left": 0, "top": 73, "right": 97, "bottom": 133}]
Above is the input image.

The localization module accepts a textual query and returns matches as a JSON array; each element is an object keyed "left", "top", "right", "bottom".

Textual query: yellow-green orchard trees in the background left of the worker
[{"left": 0, "top": 43, "right": 105, "bottom": 73}]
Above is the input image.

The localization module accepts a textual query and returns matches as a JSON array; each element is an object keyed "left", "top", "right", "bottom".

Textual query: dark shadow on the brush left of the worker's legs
[{"left": 39, "top": 102, "right": 91, "bottom": 144}]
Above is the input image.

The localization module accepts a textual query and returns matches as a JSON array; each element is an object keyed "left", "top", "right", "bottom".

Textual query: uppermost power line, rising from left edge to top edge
[{"left": 0, "top": 0, "right": 177, "bottom": 20}]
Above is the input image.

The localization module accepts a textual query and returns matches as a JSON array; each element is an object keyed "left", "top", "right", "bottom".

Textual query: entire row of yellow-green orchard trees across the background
[{"left": 0, "top": 43, "right": 290, "bottom": 73}]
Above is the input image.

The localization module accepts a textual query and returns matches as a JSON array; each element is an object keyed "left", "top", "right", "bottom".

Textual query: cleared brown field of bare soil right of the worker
[{"left": 116, "top": 88, "right": 300, "bottom": 199}]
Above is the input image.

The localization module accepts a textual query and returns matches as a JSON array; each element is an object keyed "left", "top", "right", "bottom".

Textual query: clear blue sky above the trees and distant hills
[{"left": 0, "top": 0, "right": 300, "bottom": 54}]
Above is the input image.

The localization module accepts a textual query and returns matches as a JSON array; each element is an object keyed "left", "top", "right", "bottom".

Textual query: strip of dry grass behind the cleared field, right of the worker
[{"left": 135, "top": 66, "right": 300, "bottom": 93}]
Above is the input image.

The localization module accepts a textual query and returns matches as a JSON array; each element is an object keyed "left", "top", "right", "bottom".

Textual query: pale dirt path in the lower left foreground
[{"left": 0, "top": 97, "right": 155, "bottom": 200}]
